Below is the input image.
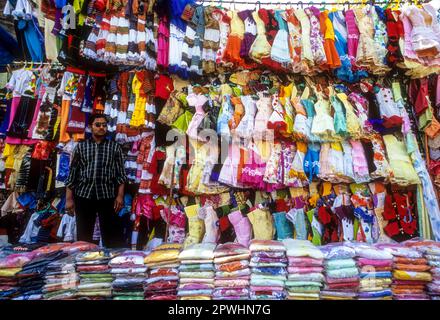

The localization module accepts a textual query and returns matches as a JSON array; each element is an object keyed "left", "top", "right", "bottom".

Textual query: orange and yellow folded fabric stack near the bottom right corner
[{"left": 378, "top": 244, "right": 432, "bottom": 300}]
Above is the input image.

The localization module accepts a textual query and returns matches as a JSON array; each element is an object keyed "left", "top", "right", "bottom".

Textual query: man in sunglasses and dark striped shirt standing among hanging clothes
[{"left": 66, "top": 114, "right": 127, "bottom": 248}]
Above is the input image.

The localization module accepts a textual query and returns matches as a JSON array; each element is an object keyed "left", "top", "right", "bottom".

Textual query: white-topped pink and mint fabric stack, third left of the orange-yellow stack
[{"left": 283, "top": 239, "right": 324, "bottom": 300}]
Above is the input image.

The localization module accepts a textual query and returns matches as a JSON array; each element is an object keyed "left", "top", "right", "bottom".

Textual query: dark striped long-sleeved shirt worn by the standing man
[{"left": 66, "top": 139, "right": 127, "bottom": 200}]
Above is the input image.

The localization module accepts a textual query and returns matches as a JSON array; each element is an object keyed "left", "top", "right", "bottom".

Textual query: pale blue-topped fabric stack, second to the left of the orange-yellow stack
[{"left": 320, "top": 243, "right": 360, "bottom": 300}]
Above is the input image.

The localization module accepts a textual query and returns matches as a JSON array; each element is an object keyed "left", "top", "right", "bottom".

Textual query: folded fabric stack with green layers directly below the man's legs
[{"left": 76, "top": 250, "right": 116, "bottom": 300}]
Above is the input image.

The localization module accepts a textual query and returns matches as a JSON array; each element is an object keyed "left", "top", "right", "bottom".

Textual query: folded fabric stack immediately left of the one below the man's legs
[{"left": 43, "top": 254, "right": 79, "bottom": 300}]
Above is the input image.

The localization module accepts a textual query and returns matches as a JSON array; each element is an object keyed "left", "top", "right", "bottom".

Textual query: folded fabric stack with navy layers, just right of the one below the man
[{"left": 109, "top": 251, "right": 148, "bottom": 300}]
